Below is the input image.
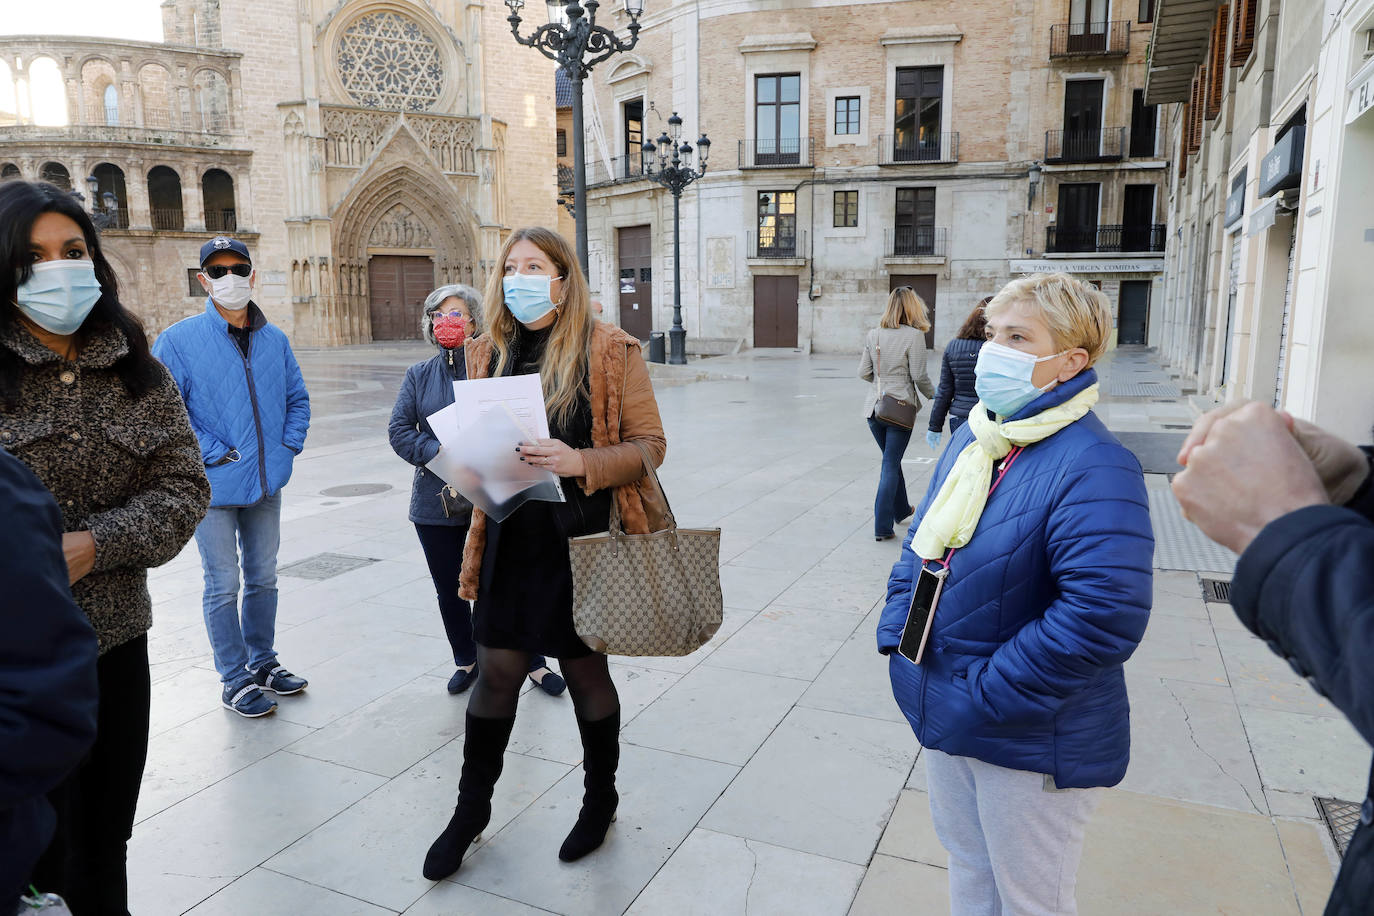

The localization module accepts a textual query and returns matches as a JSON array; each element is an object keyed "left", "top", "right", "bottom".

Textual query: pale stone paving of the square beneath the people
[{"left": 123, "top": 346, "right": 1369, "bottom": 916}]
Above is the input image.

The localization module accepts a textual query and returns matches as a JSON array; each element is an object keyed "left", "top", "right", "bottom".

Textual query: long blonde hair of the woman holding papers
[{"left": 485, "top": 225, "right": 595, "bottom": 424}]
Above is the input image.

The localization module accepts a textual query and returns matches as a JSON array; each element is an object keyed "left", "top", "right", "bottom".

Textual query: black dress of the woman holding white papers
[{"left": 473, "top": 328, "right": 613, "bottom": 658}]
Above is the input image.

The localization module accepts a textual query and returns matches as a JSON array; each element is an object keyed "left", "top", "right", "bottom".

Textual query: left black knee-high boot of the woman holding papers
[{"left": 423, "top": 713, "right": 515, "bottom": 882}]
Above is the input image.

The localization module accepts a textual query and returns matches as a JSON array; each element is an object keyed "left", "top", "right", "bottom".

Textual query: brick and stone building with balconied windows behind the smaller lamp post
[{"left": 574, "top": 0, "right": 1168, "bottom": 352}]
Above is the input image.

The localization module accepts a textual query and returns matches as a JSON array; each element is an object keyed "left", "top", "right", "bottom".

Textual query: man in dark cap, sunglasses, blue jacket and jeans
[{"left": 153, "top": 236, "right": 311, "bottom": 718}]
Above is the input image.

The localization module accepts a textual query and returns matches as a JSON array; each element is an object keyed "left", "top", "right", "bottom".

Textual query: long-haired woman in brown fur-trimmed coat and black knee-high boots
[{"left": 423, "top": 228, "right": 666, "bottom": 880}]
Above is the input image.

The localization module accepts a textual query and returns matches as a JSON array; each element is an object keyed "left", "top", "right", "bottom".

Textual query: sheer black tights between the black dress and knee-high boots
[{"left": 467, "top": 644, "right": 620, "bottom": 722}]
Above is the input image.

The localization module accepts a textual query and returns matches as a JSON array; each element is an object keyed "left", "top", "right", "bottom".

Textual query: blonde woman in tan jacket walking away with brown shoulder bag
[{"left": 859, "top": 286, "right": 936, "bottom": 541}]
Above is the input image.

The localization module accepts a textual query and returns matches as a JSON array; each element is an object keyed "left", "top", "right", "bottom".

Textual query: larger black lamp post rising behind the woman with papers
[{"left": 506, "top": 0, "right": 644, "bottom": 272}]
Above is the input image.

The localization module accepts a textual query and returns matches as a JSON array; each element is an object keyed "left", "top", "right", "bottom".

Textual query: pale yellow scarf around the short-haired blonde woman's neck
[{"left": 911, "top": 382, "right": 1098, "bottom": 560}]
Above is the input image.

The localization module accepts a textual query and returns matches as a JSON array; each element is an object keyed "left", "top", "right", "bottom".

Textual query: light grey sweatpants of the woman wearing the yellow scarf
[{"left": 922, "top": 748, "right": 1101, "bottom": 916}]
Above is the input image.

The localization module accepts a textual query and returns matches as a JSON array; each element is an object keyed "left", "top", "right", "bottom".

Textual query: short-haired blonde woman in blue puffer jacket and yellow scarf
[{"left": 878, "top": 275, "right": 1154, "bottom": 916}]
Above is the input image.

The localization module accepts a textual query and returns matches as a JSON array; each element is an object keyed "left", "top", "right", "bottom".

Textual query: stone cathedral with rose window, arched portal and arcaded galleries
[{"left": 0, "top": 0, "right": 556, "bottom": 345}]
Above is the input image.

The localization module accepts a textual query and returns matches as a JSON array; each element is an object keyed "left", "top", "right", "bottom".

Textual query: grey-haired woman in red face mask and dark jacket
[{"left": 387, "top": 283, "right": 567, "bottom": 696}]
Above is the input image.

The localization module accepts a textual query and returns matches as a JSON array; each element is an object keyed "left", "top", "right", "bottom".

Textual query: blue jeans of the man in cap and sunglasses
[{"left": 195, "top": 490, "right": 282, "bottom": 688}]
